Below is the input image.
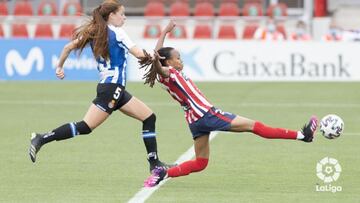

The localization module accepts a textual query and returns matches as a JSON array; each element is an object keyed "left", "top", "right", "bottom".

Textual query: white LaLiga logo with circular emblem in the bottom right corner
[{"left": 316, "top": 157, "right": 342, "bottom": 193}]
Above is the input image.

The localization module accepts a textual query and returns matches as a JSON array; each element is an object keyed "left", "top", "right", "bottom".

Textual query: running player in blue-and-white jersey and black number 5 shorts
[{"left": 29, "top": 0, "right": 172, "bottom": 171}]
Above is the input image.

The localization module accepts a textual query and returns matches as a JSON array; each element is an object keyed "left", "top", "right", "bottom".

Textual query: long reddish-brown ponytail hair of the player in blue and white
[{"left": 72, "top": 0, "right": 123, "bottom": 59}]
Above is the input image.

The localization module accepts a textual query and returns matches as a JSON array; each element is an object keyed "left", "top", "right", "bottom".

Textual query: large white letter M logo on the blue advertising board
[{"left": 5, "top": 47, "right": 44, "bottom": 76}]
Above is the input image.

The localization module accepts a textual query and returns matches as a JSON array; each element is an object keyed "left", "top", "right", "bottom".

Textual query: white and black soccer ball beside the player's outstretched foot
[{"left": 320, "top": 114, "right": 344, "bottom": 139}]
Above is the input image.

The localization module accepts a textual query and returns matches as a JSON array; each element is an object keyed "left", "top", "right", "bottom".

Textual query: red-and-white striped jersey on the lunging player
[{"left": 159, "top": 67, "right": 213, "bottom": 124}]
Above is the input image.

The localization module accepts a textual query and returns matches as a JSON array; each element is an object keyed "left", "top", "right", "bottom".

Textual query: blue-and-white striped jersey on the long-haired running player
[{"left": 96, "top": 25, "right": 135, "bottom": 87}]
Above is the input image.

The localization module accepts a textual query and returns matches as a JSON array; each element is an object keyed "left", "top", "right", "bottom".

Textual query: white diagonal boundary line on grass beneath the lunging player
[{"left": 128, "top": 132, "right": 218, "bottom": 203}]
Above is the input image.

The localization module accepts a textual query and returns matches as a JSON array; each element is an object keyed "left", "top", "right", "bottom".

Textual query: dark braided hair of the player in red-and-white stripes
[{"left": 139, "top": 47, "right": 174, "bottom": 87}]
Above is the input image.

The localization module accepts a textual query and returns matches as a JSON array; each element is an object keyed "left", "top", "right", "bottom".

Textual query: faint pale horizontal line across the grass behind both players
[{"left": 0, "top": 100, "right": 360, "bottom": 108}]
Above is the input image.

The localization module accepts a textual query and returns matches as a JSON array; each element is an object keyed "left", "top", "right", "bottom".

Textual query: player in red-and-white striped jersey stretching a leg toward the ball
[{"left": 142, "top": 21, "right": 317, "bottom": 187}]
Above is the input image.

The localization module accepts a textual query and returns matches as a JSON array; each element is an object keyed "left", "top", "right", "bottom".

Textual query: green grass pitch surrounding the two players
[{"left": 0, "top": 82, "right": 360, "bottom": 203}]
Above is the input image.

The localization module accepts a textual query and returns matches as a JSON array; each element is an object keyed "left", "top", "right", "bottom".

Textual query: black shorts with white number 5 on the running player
[{"left": 93, "top": 83, "right": 132, "bottom": 114}]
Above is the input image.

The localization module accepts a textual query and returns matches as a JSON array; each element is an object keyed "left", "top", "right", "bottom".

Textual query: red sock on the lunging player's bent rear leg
[{"left": 167, "top": 158, "right": 209, "bottom": 177}]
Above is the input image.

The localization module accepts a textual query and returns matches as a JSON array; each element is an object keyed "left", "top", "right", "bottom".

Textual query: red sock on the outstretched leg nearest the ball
[{"left": 253, "top": 121, "right": 297, "bottom": 140}]
